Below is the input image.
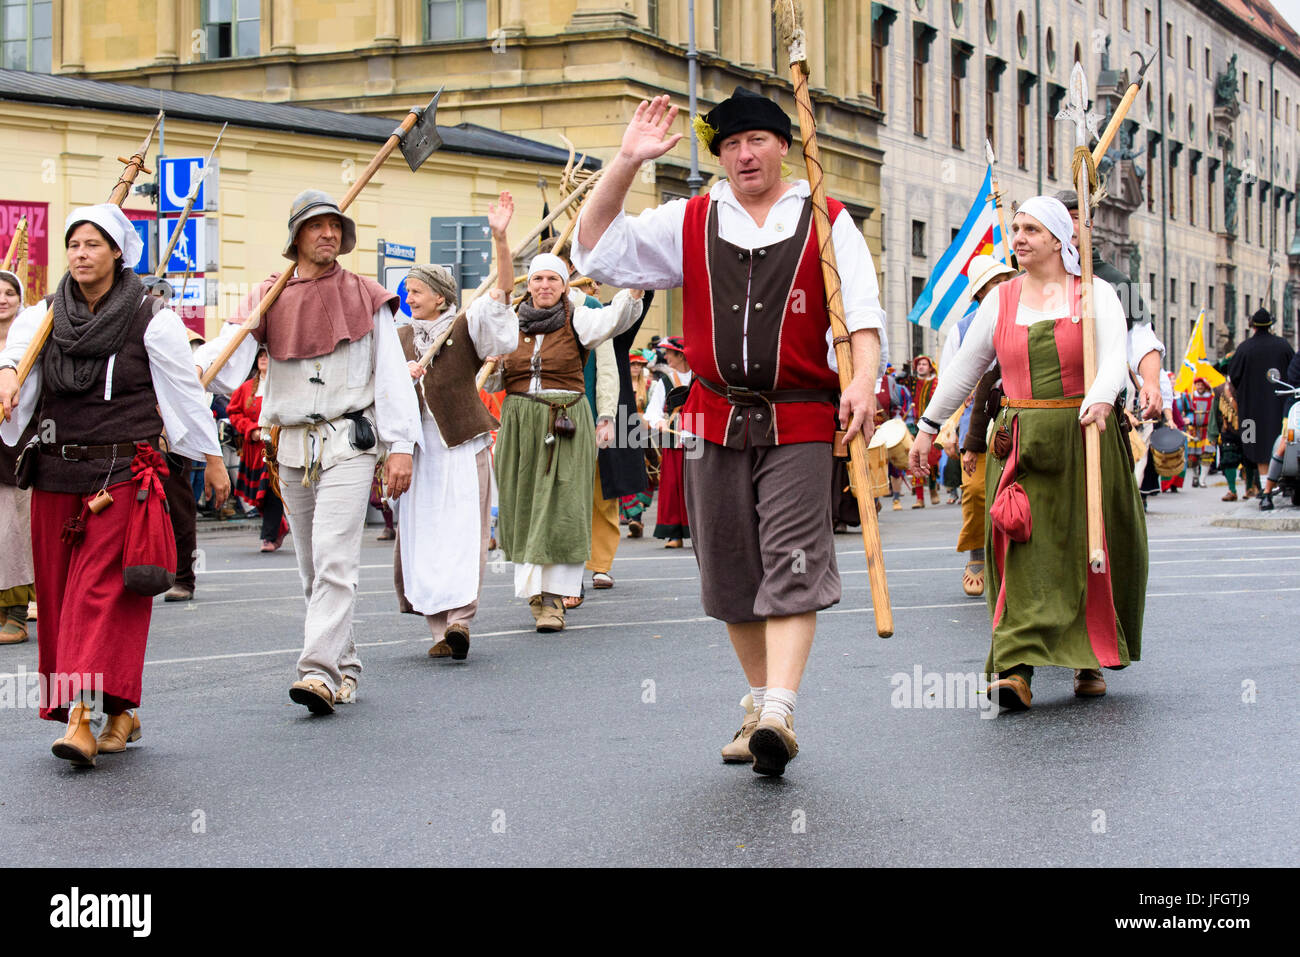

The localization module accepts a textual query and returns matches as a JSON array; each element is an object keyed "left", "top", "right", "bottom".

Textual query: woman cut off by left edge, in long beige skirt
[{"left": 0, "top": 269, "right": 36, "bottom": 645}]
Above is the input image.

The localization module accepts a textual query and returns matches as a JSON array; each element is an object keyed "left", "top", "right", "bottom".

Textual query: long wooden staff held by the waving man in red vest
[{"left": 776, "top": 0, "right": 893, "bottom": 638}]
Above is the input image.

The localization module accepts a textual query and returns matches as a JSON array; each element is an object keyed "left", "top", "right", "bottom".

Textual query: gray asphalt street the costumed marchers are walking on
[{"left": 0, "top": 478, "right": 1300, "bottom": 867}]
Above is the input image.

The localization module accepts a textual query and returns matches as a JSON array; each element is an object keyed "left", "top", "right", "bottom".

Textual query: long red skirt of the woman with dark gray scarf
[{"left": 31, "top": 481, "right": 153, "bottom": 722}]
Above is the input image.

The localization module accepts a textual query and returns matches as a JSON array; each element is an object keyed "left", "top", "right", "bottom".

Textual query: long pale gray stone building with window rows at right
[{"left": 872, "top": 0, "right": 1300, "bottom": 367}]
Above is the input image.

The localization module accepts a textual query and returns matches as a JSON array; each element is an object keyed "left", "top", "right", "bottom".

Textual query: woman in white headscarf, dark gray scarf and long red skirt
[{"left": 0, "top": 203, "right": 230, "bottom": 767}]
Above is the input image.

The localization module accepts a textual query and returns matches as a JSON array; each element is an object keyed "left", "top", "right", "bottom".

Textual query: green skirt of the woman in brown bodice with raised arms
[{"left": 494, "top": 391, "right": 595, "bottom": 564}]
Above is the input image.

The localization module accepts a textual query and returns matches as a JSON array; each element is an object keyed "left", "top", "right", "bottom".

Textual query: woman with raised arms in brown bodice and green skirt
[{"left": 469, "top": 209, "right": 641, "bottom": 632}]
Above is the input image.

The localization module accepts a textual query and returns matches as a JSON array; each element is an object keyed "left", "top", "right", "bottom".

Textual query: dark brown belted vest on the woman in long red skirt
[{"left": 35, "top": 296, "right": 163, "bottom": 494}]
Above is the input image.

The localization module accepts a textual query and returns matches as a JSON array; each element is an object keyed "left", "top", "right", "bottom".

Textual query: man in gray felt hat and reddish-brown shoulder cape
[{"left": 195, "top": 190, "right": 423, "bottom": 714}]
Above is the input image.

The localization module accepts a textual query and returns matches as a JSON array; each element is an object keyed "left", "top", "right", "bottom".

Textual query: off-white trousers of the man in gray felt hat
[{"left": 280, "top": 454, "right": 377, "bottom": 692}]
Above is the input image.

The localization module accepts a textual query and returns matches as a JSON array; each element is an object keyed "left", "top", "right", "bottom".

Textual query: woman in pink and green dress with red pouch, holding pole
[{"left": 911, "top": 196, "right": 1147, "bottom": 710}]
